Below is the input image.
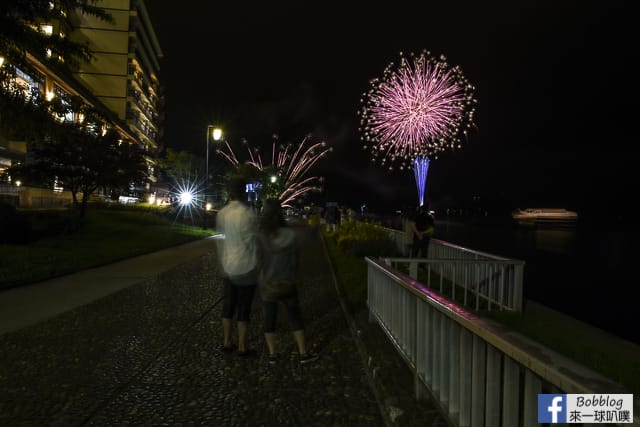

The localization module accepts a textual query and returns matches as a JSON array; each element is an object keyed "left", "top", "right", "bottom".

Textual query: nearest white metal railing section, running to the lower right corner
[{"left": 365, "top": 257, "right": 640, "bottom": 427}]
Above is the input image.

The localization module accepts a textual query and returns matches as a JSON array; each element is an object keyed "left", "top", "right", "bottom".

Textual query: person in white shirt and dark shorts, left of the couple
[{"left": 216, "top": 178, "right": 259, "bottom": 357}]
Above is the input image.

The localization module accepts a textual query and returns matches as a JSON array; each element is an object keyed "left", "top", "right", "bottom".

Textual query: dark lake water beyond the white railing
[{"left": 434, "top": 220, "right": 640, "bottom": 344}]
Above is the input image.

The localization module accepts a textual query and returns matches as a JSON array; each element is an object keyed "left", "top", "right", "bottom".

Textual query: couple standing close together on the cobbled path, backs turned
[{"left": 216, "top": 178, "right": 318, "bottom": 364}]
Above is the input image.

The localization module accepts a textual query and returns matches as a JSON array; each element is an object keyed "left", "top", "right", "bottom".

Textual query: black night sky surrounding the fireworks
[{"left": 147, "top": 0, "right": 639, "bottom": 214}]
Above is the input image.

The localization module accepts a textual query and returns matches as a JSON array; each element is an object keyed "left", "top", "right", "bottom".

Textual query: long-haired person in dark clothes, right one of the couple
[{"left": 258, "top": 199, "right": 318, "bottom": 364}]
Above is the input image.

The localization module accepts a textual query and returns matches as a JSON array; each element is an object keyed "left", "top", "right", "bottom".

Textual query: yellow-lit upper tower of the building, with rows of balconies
[{"left": 71, "top": 0, "right": 162, "bottom": 163}]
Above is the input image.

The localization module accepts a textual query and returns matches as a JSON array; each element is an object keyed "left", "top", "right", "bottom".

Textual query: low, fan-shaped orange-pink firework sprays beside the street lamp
[{"left": 218, "top": 135, "right": 333, "bottom": 207}]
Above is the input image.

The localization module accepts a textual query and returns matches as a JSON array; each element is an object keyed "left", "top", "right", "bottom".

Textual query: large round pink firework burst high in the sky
[{"left": 358, "top": 51, "right": 477, "bottom": 169}]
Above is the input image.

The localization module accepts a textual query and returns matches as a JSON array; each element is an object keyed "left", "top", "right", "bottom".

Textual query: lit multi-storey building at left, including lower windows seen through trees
[{"left": 0, "top": 0, "right": 163, "bottom": 206}]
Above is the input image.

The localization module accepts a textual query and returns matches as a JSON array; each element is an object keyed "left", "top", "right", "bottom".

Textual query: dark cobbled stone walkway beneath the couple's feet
[{"left": 0, "top": 229, "right": 447, "bottom": 427}]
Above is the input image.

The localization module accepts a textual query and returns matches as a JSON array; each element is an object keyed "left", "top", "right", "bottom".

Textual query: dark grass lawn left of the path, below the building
[{"left": 0, "top": 205, "right": 213, "bottom": 289}]
